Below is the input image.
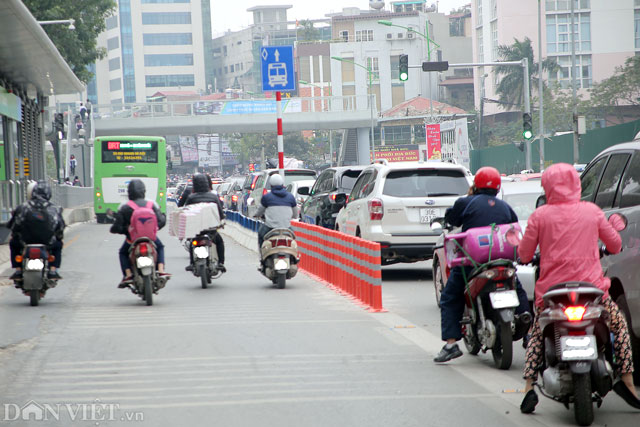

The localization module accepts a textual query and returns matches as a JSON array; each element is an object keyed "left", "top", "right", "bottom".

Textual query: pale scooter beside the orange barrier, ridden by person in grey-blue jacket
[{"left": 260, "top": 228, "right": 300, "bottom": 289}]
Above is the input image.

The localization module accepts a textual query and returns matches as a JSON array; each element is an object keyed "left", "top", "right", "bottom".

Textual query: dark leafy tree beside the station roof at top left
[{"left": 23, "top": 0, "right": 116, "bottom": 83}]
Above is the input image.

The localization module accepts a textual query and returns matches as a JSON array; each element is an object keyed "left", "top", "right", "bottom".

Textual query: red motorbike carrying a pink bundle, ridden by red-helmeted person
[{"left": 431, "top": 218, "right": 532, "bottom": 370}]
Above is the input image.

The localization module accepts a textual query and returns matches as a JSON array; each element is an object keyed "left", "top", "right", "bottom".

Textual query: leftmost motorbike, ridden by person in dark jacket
[{"left": 14, "top": 244, "right": 58, "bottom": 307}]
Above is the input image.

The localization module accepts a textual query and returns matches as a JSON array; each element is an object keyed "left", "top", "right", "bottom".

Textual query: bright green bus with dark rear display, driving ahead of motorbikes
[{"left": 93, "top": 136, "right": 167, "bottom": 223}]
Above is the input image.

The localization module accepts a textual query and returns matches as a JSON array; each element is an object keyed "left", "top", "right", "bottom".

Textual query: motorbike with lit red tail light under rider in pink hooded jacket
[{"left": 516, "top": 213, "right": 627, "bottom": 426}]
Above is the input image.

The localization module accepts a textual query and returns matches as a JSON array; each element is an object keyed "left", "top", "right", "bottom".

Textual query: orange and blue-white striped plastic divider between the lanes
[{"left": 223, "top": 211, "right": 386, "bottom": 312}]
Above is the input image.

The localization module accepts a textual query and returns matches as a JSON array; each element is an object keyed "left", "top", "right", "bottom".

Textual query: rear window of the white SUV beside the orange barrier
[{"left": 382, "top": 169, "right": 469, "bottom": 197}]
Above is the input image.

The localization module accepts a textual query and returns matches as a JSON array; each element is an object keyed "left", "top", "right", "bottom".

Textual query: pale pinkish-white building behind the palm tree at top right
[{"left": 471, "top": 0, "right": 640, "bottom": 115}]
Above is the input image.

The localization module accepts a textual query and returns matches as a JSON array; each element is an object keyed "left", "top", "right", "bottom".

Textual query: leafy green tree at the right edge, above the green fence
[{"left": 591, "top": 56, "right": 640, "bottom": 122}]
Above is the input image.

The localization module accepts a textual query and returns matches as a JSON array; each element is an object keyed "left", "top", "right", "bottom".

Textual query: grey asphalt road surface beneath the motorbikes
[{"left": 0, "top": 223, "right": 638, "bottom": 427}]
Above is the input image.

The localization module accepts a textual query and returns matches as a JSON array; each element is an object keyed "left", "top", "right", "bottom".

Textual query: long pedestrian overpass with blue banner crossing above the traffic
[{"left": 92, "top": 95, "right": 378, "bottom": 163}]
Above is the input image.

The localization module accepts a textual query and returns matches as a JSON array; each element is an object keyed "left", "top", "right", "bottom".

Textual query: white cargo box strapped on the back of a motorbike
[{"left": 169, "top": 203, "right": 221, "bottom": 239}]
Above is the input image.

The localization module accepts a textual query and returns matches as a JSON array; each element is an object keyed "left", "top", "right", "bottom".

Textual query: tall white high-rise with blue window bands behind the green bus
[{"left": 88, "top": 0, "right": 213, "bottom": 104}]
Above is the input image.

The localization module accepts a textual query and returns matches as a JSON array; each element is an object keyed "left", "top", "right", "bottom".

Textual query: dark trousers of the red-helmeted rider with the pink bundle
[{"left": 440, "top": 267, "right": 530, "bottom": 341}]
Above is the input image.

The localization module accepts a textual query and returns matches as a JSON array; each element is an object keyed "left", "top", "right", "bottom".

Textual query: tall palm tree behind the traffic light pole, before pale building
[{"left": 495, "top": 37, "right": 558, "bottom": 110}]
